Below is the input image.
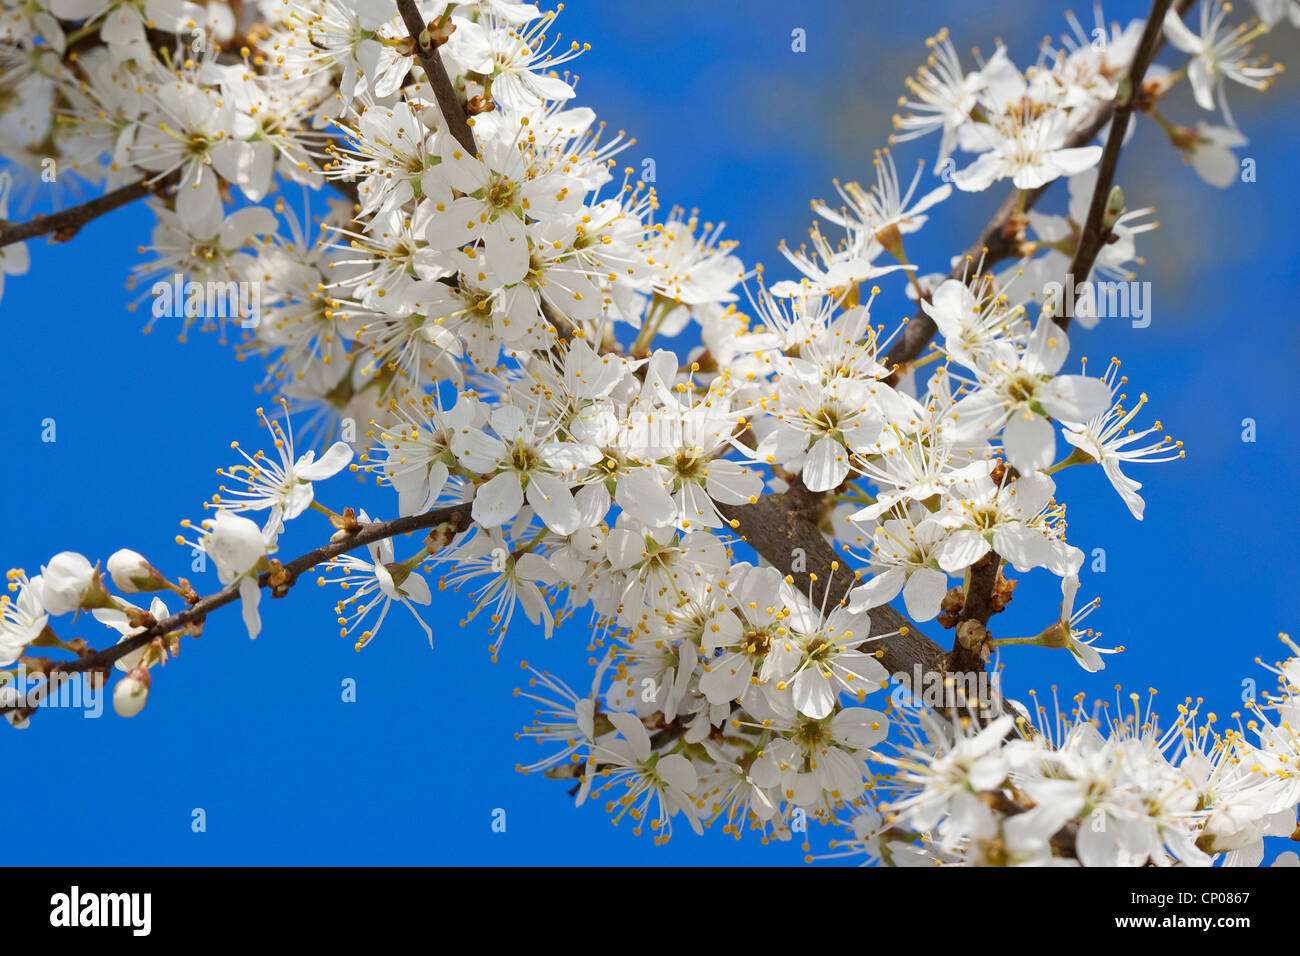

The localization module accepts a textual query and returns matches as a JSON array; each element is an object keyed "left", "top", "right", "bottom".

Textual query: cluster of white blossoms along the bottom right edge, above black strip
[{"left": 832, "top": 635, "right": 1300, "bottom": 866}]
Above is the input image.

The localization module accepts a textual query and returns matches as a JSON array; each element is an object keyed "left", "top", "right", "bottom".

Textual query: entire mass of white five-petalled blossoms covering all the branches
[{"left": 0, "top": 0, "right": 1300, "bottom": 862}]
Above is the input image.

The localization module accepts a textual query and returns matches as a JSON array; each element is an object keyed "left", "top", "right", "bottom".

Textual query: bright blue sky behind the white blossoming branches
[{"left": 0, "top": 0, "right": 1300, "bottom": 865}]
